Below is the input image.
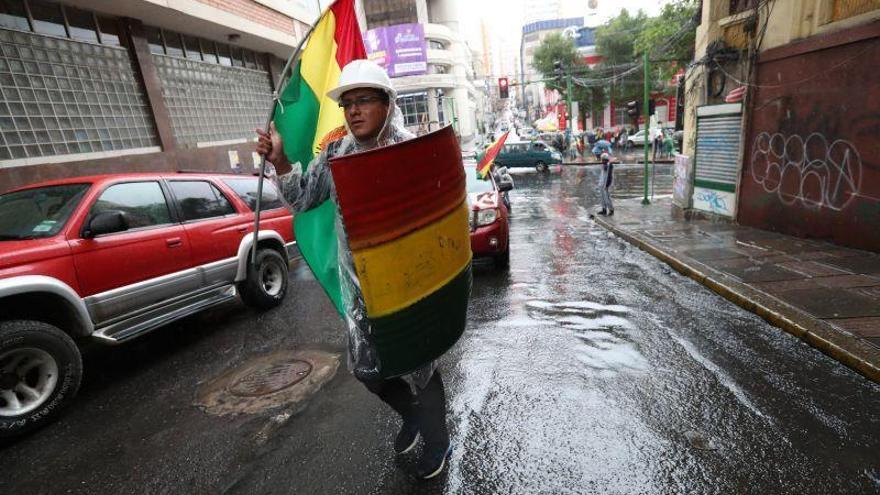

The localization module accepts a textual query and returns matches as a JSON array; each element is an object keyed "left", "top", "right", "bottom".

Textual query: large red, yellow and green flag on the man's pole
[{"left": 274, "top": 0, "right": 366, "bottom": 314}]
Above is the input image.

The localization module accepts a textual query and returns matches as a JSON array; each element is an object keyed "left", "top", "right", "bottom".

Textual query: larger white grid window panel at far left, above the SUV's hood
[{"left": 0, "top": 29, "right": 158, "bottom": 160}]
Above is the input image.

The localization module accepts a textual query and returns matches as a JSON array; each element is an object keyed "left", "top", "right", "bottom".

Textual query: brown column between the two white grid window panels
[{"left": 122, "top": 17, "right": 177, "bottom": 151}]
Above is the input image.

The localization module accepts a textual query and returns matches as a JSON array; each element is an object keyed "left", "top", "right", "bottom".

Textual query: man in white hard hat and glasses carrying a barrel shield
[{"left": 257, "top": 60, "right": 452, "bottom": 479}]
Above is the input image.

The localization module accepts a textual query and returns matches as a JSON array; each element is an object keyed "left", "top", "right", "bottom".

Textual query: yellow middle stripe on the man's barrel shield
[{"left": 352, "top": 202, "right": 471, "bottom": 318}]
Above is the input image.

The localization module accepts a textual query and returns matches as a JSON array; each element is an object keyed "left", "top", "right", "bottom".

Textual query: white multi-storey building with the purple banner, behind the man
[{"left": 357, "top": 0, "right": 485, "bottom": 142}]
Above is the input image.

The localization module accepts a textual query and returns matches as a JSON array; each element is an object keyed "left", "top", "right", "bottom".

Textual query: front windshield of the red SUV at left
[{"left": 0, "top": 184, "right": 89, "bottom": 241}]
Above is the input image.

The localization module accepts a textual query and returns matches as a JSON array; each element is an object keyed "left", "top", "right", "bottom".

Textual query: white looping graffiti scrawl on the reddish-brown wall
[{"left": 749, "top": 132, "right": 862, "bottom": 211}]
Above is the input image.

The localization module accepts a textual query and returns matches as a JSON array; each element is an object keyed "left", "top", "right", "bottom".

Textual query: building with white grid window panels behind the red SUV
[{"left": 0, "top": 0, "right": 318, "bottom": 191}]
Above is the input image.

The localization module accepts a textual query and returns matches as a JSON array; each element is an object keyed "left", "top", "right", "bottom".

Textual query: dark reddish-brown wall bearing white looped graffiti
[{"left": 735, "top": 24, "right": 880, "bottom": 252}]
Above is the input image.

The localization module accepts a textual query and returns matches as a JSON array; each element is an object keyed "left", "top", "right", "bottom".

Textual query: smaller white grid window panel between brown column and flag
[{"left": 153, "top": 54, "right": 272, "bottom": 146}]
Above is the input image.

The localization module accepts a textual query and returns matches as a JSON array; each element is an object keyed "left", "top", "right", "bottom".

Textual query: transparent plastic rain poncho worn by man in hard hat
[{"left": 279, "top": 98, "right": 436, "bottom": 388}]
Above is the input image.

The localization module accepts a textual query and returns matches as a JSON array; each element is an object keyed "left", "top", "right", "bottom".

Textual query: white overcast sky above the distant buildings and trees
[{"left": 458, "top": 0, "right": 668, "bottom": 78}]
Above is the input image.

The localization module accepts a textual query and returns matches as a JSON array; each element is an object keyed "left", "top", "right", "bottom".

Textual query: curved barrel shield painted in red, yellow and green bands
[{"left": 330, "top": 126, "right": 471, "bottom": 378}]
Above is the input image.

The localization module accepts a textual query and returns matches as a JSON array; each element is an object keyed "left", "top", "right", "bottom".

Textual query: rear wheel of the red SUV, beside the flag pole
[{"left": 238, "top": 249, "right": 287, "bottom": 309}]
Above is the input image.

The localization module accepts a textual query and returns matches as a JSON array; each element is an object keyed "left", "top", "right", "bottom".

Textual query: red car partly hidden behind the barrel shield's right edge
[{"left": 465, "top": 166, "right": 513, "bottom": 269}]
